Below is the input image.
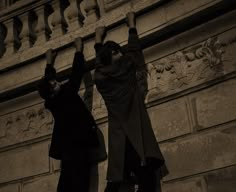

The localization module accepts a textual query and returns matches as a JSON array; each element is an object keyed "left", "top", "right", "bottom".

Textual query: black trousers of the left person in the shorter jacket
[{"left": 57, "top": 152, "right": 90, "bottom": 192}]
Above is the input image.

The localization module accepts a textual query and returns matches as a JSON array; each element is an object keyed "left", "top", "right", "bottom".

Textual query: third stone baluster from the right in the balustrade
[{"left": 51, "top": 0, "right": 67, "bottom": 39}]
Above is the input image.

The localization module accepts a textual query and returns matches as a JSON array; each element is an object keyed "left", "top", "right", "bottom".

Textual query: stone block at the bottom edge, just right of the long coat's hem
[{"left": 162, "top": 177, "right": 206, "bottom": 192}]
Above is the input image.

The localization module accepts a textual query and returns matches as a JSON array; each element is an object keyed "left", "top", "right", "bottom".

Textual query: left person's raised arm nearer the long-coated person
[{"left": 69, "top": 37, "right": 85, "bottom": 91}]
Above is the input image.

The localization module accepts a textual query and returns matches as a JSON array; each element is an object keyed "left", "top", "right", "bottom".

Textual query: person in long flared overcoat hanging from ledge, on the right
[{"left": 95, "top": 13, "right": 168, "bottom": 192}]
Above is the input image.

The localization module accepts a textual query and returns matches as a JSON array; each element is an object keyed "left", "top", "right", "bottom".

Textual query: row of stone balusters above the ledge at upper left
[{"left": 0, "top": 0, "right": 98, "bottom": 58}]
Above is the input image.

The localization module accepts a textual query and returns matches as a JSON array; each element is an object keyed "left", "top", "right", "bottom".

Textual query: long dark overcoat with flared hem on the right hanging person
[{"left": 95, "top": 29, "right": 168, "bottom": 181}]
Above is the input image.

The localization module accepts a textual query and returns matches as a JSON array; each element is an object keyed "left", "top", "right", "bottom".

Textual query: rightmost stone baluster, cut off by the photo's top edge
[{"left": 84, "top": 0, "right": 99, "bottom": 25}]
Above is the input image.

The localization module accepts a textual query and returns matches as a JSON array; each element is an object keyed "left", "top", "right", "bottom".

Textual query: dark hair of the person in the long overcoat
[{"left": 98, "top": 41, "right": 124, "bottom": 65}]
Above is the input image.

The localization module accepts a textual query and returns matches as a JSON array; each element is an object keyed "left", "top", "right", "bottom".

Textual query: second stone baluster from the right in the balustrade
[{"left": 65, "top": 0, "right": 83, "bottom": 31}]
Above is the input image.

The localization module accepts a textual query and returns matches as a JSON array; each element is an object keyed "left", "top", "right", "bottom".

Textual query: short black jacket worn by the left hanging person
[{"left": 45, "top": 52, "right": 98, "bottom": 159}]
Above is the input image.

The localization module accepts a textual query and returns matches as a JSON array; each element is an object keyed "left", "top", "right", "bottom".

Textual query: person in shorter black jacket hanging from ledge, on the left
[{"left": 39, "top": 38, "right": 104, "bottom": 192}]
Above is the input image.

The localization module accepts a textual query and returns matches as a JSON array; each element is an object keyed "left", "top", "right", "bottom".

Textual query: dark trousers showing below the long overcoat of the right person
[{"left": 105, "top": 139, "right": 161, "bottom": 192}]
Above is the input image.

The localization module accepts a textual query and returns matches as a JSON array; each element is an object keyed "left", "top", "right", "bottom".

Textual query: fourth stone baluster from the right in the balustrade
[{"left": 35, "top": 6, "right": 51, "bottom": 45}]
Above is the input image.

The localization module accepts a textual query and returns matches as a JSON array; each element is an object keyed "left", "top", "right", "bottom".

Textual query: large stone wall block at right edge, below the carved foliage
[{"left": 191, "top": 79, "right": 236, "bottom": 129}]
